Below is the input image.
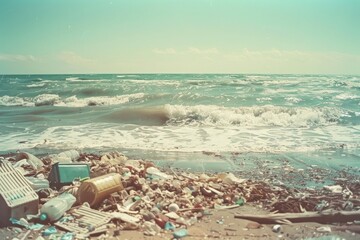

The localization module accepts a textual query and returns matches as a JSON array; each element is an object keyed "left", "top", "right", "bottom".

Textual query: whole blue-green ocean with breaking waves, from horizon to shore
[{"left": 0, "top": 74, "right": 360, "bottom": 174}]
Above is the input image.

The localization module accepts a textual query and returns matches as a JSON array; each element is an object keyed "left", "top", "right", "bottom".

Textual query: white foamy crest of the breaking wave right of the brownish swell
[{"left": 165, "top": 105, "right": 343, "bottom": 127}]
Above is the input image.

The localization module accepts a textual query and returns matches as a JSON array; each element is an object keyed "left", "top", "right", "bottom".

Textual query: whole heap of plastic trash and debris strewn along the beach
[{"left": 0, "top": 150, "right": 360, "bottom": 240}]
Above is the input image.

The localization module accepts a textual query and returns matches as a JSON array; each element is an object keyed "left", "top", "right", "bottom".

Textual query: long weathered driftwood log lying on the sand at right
[{"left": 235, "top": 210, "right": 360, "bottom": 224}]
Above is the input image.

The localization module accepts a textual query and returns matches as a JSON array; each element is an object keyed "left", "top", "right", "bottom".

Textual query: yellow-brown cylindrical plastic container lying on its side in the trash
[{"left": 77, "top": 173, "right": 123, "bottom": 207}]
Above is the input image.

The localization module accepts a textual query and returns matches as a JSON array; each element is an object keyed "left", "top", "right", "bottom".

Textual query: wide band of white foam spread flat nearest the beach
[{"left": 0, "top": 123, "right": 360, "bottom": 153}]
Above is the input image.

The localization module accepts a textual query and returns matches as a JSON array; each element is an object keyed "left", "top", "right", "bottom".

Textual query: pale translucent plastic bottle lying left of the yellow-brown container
[{"left": 40, "top": 192, "right": 76, "bottom": 222}]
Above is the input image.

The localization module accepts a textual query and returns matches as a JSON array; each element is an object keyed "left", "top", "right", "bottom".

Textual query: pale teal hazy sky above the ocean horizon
[{"left": 0, "top": 0, "right": 360, "bottom": 74}]
